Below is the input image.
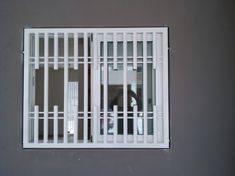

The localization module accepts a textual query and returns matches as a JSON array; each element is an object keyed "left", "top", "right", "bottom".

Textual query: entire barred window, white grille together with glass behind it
[{"left": 23, "top": 27, "right": 169, "bottom": 148}]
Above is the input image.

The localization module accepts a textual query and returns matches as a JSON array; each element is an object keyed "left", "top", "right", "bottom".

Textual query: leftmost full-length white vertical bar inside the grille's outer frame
[{"left": 43, "top": 33, "right": 49, "bottom": 143}]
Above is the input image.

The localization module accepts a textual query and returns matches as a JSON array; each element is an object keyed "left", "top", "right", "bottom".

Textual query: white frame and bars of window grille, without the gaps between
[{"left": 23, "top": 27, "right": 169, "bottom": 148}]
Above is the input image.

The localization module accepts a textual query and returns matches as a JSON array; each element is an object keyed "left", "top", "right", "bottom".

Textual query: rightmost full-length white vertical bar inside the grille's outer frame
[{"left": 143, "top": 33, "right": 148, "bottom": 143}]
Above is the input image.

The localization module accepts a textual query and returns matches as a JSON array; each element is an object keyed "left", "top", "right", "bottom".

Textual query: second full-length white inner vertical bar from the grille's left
[{"left": 64, "top": 33, "right": 69, "bottom": 143}]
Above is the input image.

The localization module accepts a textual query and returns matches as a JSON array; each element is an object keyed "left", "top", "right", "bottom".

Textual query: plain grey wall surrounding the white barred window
[{"left": 0, "top": 0, "right": 235, "bottom": 176}]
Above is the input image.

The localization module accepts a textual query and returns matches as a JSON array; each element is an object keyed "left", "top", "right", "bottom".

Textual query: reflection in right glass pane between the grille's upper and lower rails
[{"left": 101, "top": 64, "right": 143, "bottom": 111}]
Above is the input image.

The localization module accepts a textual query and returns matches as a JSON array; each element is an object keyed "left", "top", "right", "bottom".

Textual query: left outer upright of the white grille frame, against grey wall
[{"left": 24, "top": 31, "right": 30, "bottom": 146}]
